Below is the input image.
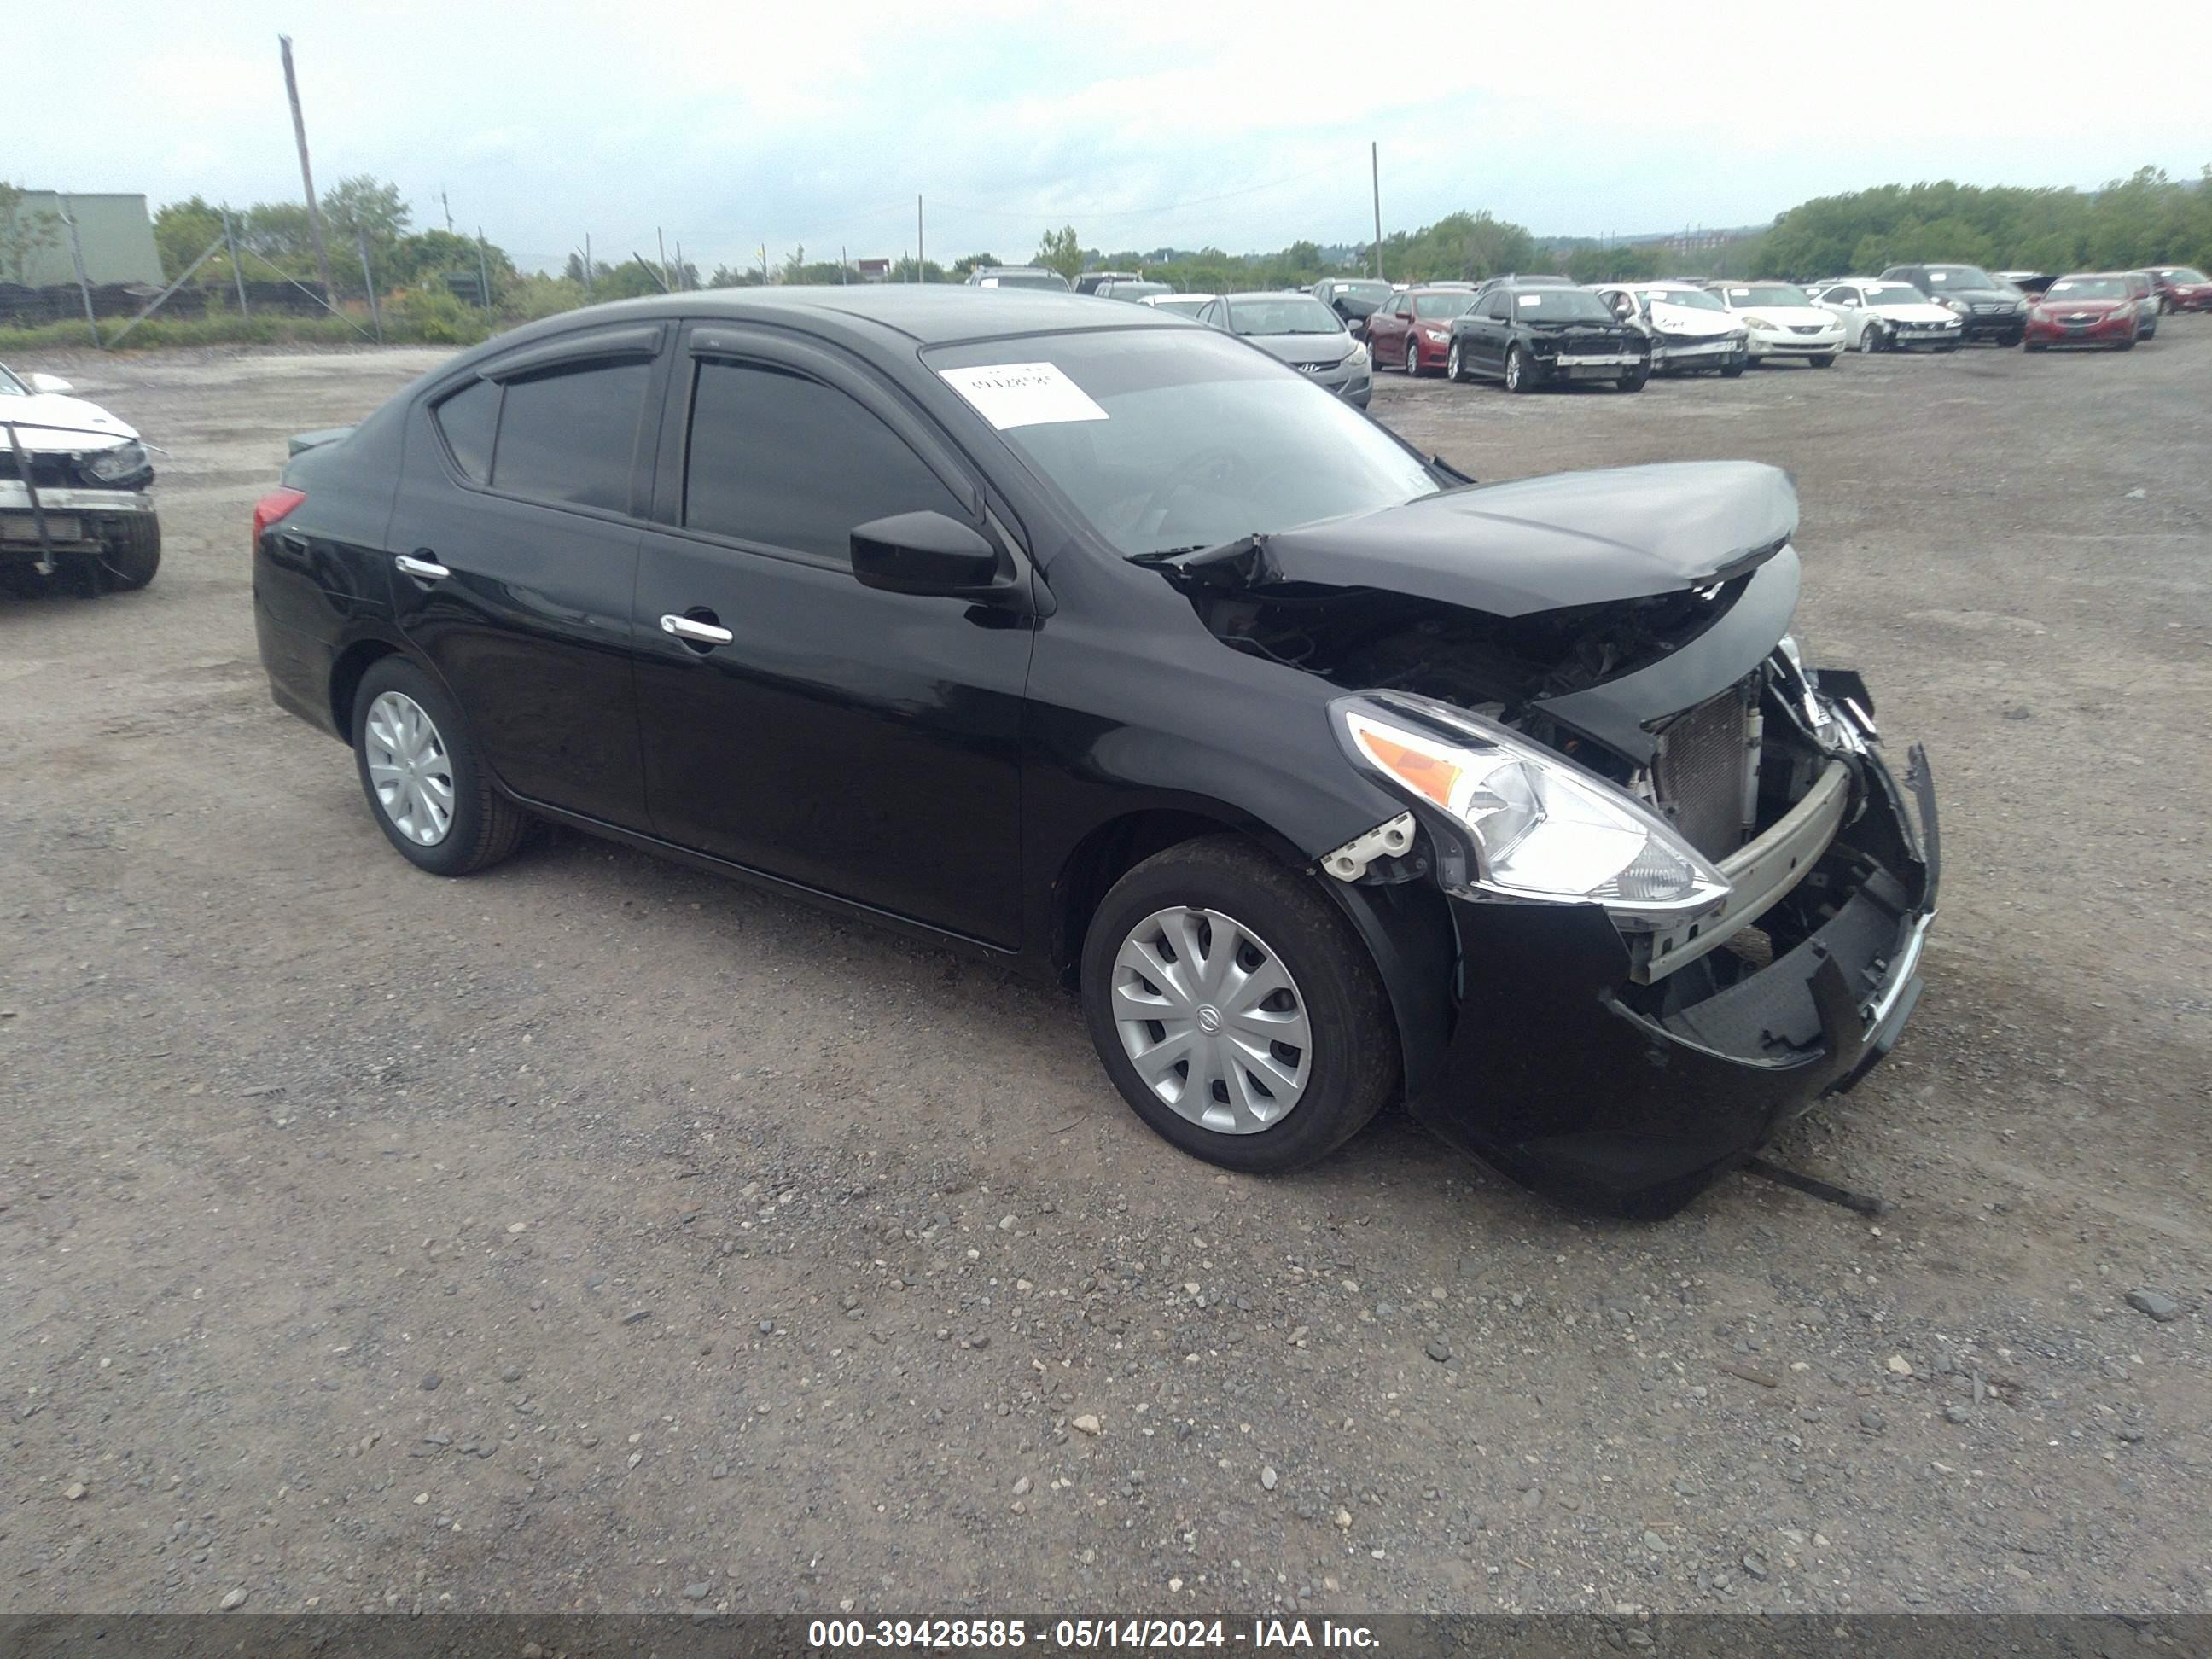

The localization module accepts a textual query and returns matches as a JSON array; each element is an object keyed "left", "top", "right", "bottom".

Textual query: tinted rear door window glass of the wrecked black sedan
[{"left": 491, "top": 363, "right": 653, "bottom": 513}]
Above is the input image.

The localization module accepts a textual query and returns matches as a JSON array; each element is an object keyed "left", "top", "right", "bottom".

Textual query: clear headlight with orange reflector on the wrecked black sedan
[{"left": 1334, "top": 692, "right": 1730, "bottom": 929}]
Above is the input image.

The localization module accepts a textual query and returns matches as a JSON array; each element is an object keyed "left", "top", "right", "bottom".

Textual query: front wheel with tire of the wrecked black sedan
[{"left": 1081, "top": 836, "right": 1400, "bottom": 1173}]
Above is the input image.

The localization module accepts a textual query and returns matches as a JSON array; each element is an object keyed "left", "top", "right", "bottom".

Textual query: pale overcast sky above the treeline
[{"left": 17, "top": 0, "right": 2212, "bottom": 270}]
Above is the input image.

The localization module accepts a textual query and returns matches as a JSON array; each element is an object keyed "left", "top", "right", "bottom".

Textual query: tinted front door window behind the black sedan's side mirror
[{"left": 684, "top": 363, "right": 969, "bottom": 562}]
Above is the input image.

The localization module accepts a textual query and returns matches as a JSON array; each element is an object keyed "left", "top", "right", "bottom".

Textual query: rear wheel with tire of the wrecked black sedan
[{"left": 354, "top": 657, "right": 531, "bottom": 876}]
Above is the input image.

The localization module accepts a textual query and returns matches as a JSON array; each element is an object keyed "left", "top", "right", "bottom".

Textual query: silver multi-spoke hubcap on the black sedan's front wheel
[{"left": 1113, "top": 909, "right": 1314, "bottom": 1135}]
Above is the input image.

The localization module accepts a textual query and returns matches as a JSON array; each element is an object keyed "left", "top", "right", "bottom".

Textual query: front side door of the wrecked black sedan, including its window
[{"left": 635, "top": 325, "right": 1031, "bottom": 946}]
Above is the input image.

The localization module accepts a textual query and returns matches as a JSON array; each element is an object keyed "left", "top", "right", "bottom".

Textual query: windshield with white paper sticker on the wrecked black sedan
[{"left": 923, "top": 328, "right": 1435, "bottom": 553}]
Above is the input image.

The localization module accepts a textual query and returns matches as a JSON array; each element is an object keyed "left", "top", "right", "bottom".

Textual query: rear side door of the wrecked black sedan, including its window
[{"left": 385, "top": 325, "right": 668, "bottom": 830}]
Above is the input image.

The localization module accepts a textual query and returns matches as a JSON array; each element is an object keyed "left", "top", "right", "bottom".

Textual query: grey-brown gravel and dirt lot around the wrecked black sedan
[{"left": 0, "top": 331, "right": 2212, "bottom": 1613}]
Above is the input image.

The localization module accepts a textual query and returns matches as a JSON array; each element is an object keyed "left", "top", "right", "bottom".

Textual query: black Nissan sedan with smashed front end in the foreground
[{"left": 252, "top": 288, "right": 1936, "bottom": 1214}]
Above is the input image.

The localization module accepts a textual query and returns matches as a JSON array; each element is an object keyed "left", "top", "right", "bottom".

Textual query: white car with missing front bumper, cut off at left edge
[{"left": 0, "top": 365, "right": 161, "bottom": 593}]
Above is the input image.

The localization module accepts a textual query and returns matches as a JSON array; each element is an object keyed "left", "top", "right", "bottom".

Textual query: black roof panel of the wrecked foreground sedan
[{"left": 498, "top": 283, "right": 1161, "bottom": 345}]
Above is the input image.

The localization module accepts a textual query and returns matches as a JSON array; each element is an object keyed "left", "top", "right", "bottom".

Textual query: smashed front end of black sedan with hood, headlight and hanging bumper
[{"left": 1141, "top": 467, "right": 1938, "bottom": 1217}]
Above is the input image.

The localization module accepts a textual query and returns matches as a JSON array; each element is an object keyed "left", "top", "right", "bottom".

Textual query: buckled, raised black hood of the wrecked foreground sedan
[{"left": 1166, "top": 460, "right": 1798, "bottom": 617}]
